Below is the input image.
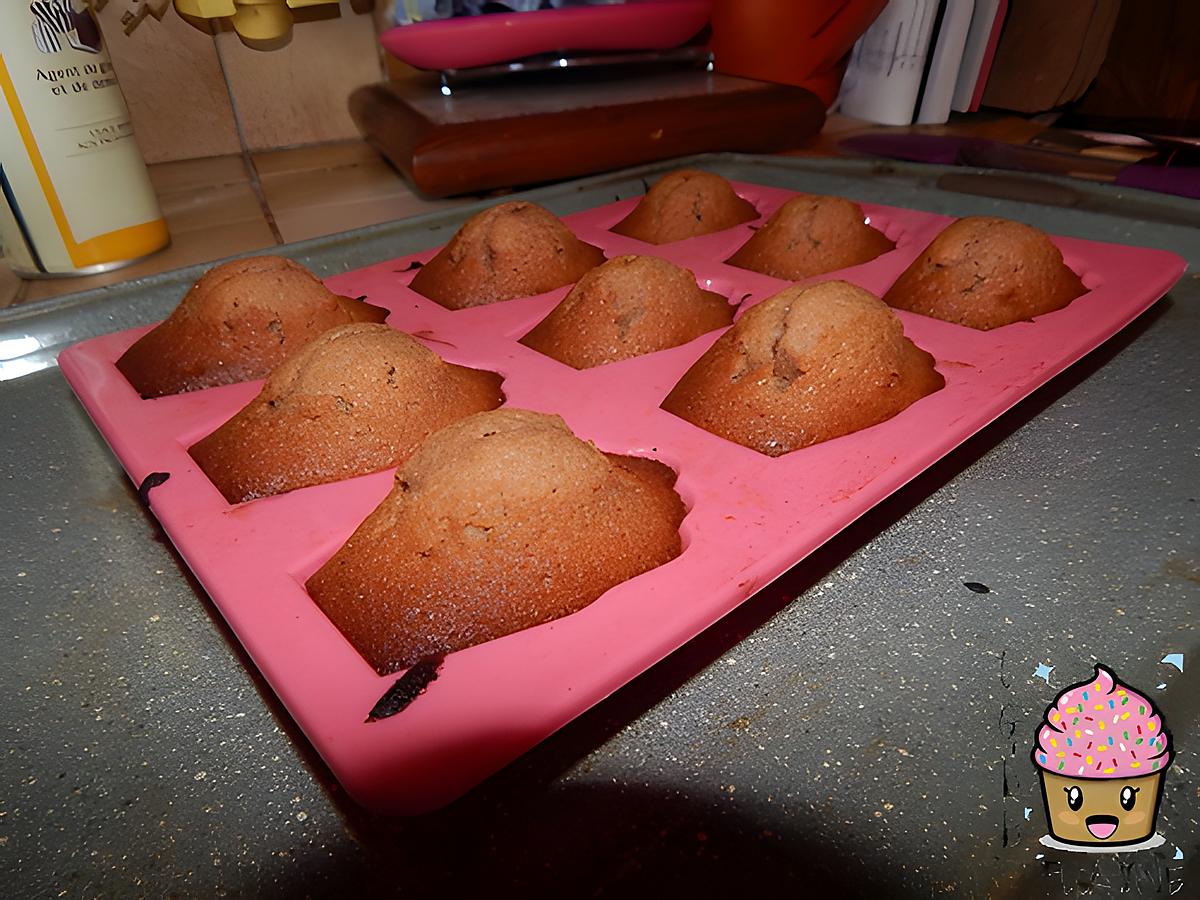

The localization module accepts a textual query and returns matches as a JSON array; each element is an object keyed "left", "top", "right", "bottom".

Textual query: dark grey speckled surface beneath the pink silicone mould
[{"left": 0, "top": 158, "right": 1200, "bottom": 898}]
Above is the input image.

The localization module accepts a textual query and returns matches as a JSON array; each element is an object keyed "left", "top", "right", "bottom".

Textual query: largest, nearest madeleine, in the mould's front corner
[{"left": 307, "top": 409, "right": 684, "bottom": 673}]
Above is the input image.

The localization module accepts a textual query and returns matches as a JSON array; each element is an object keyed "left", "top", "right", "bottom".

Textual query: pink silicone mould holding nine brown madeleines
[{"left": 60, "top": 184, "right": 1184, "bottom": 814}]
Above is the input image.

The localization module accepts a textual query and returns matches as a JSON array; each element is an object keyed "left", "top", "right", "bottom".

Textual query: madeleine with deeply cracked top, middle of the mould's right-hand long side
[{"left": 662, "top": 281, "right": 944, "bottom": 456}]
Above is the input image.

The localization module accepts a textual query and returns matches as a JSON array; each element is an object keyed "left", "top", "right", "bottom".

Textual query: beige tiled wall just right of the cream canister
[{"left": 97, "top": 0, "right": 384, "bottom": 162}]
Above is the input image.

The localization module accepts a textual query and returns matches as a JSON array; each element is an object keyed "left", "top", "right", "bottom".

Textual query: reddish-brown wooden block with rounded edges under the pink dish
[{"left": 349, "top": 70, "right": 824, "bottom": 197}]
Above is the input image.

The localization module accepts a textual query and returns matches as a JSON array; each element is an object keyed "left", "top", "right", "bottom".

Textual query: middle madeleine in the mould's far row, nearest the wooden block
[{"left": 412, "top": 200, "right": 604, "bottom": 310}]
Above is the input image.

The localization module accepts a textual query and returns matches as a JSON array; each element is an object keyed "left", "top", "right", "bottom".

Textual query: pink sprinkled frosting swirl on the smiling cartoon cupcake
[{"left": 1033, "top": 666, "right": 1171, "bottom": 778}]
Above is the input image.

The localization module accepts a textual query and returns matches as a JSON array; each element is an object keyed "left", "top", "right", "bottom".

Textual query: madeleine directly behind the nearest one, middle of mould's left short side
[{"left": 191, "top": 324, "right": 504, "bottom": 503}]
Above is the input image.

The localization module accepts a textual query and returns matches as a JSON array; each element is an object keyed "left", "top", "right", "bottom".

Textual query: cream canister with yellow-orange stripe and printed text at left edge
[{"left": 0, "top": 0, "right": 168, "bottom": 276}]
